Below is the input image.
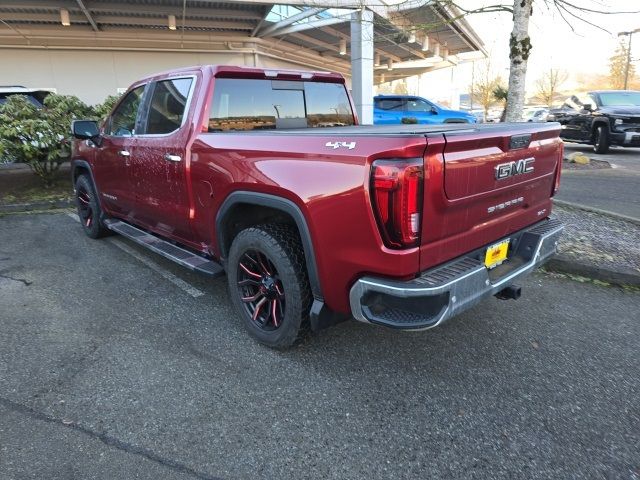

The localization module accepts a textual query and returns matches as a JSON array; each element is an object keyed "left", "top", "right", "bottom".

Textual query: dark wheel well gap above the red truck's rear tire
[{"left": 218, "top": 203, "right": 300, "bottom": 258}]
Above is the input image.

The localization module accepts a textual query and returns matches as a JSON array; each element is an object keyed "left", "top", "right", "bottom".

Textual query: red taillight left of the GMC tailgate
[{"left": 371, "top": 158, "right": 424, "bottom": 248}]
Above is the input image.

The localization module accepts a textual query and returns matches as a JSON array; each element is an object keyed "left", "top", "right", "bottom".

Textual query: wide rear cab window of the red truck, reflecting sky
[{"left": 209, "top": 78, "right": 354, "bottom": 132}]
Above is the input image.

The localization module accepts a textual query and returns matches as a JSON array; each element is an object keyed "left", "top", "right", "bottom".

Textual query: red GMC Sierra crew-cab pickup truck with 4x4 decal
[{"left": 72, "top": 66, "right": 563, "bottom": 348}]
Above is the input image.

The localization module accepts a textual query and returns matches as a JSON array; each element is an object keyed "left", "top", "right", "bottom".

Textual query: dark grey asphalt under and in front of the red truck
[{"left": 0, "top": 214, "right": 640, "bottom": 480}]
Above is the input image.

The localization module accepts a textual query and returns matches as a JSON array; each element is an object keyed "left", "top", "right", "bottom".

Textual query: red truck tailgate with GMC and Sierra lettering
[{"left": 420, "top": 123, "right": 562, "bottom": 270}]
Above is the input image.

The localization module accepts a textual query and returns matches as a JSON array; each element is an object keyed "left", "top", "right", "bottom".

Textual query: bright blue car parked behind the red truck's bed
[{"left": 373, "top": 95, "right": 477, "bottom": 125}]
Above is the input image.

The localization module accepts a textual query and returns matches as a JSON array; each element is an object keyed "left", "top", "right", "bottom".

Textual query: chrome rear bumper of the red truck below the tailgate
[{"left": 349, "top": 219, "right": 564, "bottom": 330}]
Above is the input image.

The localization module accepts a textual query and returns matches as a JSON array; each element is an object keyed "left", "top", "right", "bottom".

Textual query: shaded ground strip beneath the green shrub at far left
[{"left": 0, "top": 169, "right": 73, "bottom": 205}]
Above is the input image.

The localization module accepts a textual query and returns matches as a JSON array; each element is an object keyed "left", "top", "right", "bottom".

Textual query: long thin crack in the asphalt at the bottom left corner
[{"left": 0, "top": 397, "right": 222, "bottom": 480}]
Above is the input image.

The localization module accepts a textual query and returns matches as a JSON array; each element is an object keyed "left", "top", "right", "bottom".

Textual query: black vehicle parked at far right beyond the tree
[{"left": 547, "top": 90, "right": 640, "bottom": 153}]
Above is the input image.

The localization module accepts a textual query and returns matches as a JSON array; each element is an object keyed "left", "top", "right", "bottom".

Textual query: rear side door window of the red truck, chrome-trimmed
[{"left": 145, "top": 78, "right": 193, "bottom": 135}]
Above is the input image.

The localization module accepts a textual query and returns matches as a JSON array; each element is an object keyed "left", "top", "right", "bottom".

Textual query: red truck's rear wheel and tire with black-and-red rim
[{"left": 227, "top": 224, "right": 312, "bottom": 349}]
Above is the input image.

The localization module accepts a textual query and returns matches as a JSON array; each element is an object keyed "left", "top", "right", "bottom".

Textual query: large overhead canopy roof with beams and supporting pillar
[{"left": 0, "top": 0, "right": 486, "bottom": 120}]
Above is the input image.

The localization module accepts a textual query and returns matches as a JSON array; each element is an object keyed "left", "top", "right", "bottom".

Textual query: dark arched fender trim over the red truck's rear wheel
[{"left": 216, "top": 191, "right": 323, "bottom": 301}]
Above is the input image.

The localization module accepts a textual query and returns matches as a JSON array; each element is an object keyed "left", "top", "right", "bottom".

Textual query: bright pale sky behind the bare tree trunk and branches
[{"left": 408, "top": 0, "right": 640, "bottom": 108}]
